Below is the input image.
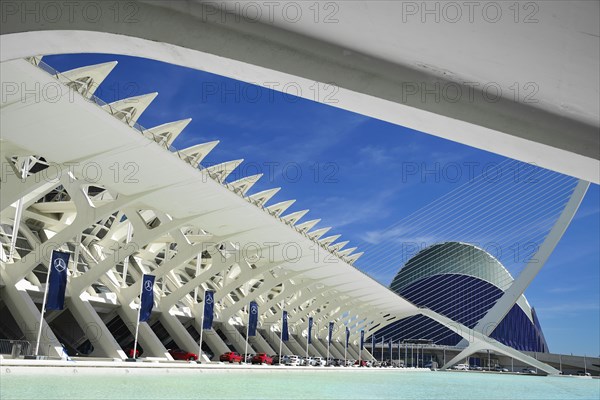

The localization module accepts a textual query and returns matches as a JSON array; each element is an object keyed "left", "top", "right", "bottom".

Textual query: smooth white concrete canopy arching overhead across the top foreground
[{"left": 0, "top": 1, "right": 600, "bottom": 183}]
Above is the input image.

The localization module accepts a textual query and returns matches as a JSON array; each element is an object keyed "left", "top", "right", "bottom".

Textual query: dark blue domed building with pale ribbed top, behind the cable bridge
[{"left": 375, "top": 242, "right": 548, "bottom": 352}]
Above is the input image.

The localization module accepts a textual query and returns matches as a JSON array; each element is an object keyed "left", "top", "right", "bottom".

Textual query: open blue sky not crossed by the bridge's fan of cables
[{"left": 44, "top": 54, "right": 600, "bottom": 356}]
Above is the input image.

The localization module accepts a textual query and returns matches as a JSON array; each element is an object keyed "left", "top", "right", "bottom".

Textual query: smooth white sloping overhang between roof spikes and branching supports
[{"left": 1, "top": 60, "right": 418, "bottom": 314}]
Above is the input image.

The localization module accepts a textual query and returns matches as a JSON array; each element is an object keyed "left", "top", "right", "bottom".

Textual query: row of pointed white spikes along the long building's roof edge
[{"left": 47, "top": 58, "right": 363, "bottom": 264}]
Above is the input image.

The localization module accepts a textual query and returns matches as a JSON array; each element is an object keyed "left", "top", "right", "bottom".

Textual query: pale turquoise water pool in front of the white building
[{"left": 0, "top": 368, "right": 600, "bottom": 400}]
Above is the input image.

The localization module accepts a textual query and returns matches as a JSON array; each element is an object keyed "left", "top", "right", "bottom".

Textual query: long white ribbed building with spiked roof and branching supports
[{"left": 0, "top": 59, "right": 572, "bottom": 373}]
